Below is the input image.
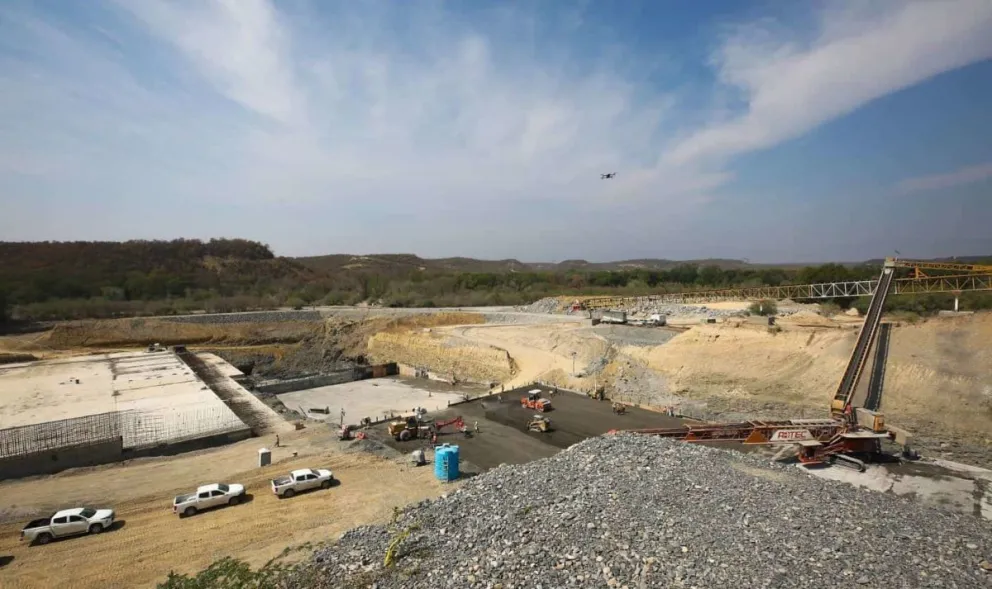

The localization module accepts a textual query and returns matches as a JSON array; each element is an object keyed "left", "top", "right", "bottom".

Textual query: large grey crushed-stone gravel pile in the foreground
[{"left": 287, "top": 435, "right": 992, "bottom": 589}]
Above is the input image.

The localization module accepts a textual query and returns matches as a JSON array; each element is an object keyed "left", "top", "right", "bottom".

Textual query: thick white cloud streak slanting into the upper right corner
[{"left": 667, "top": 0, "right": 992, "bottom": 164}]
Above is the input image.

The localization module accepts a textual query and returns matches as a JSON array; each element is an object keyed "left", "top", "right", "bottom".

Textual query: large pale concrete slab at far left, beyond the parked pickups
[{"left": 0, "top": 352, "right": 246, "bottom": 448}]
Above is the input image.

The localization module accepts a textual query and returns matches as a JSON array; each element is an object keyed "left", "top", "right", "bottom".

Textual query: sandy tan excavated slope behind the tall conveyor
[{"left": 420, "top": 310, "right": 992, "bottom": 459}]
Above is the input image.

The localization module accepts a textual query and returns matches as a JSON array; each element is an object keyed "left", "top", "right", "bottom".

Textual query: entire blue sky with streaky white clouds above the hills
[{"left": 0, "top": 0, "right": 992, "bottom": 262}]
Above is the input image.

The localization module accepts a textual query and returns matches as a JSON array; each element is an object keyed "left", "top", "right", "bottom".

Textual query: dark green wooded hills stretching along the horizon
[{"left": 0, "top": 239, "right": 992, "bottom": 324}]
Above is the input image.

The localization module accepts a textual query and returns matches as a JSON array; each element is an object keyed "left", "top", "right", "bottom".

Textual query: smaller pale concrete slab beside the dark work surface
[{"left": 279, "top": 378, "right": 465, "bottom": 424}]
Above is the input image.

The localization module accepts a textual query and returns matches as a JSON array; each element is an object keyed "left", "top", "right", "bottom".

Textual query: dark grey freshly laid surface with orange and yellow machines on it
[{"left": 375, "top": 387, "right": 682, "bottom": 472}]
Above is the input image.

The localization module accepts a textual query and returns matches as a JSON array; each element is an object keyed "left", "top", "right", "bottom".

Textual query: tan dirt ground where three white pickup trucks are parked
[{"left": 0, "top": 426, "right": 450, "bottom": 588}]
